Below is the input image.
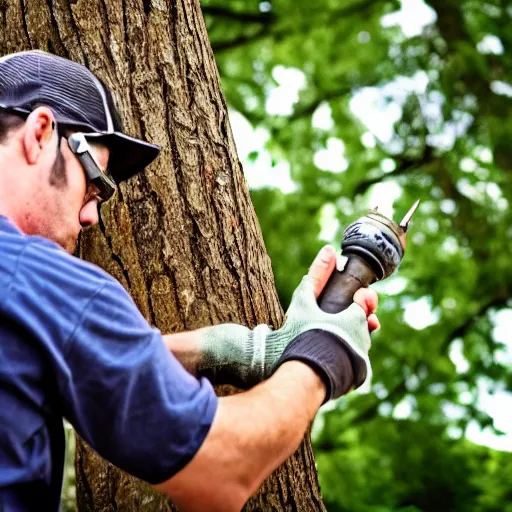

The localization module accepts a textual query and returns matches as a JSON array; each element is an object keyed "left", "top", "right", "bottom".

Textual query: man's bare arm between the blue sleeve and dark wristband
[{"left": 154, "top": 361, "right": 325, "bottom": 511}]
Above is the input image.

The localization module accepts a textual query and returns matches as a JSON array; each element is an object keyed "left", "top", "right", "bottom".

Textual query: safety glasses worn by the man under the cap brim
[{"left": 66, "top": 132, "right": 117, "bottom": 202}]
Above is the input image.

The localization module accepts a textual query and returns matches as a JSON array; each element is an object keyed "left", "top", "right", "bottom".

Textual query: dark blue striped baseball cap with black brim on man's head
[{"left": 0, "top": 50, "right": 160, "bottom": 183}]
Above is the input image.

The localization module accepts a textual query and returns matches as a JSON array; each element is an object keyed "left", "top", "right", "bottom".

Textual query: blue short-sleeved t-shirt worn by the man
[{"left": 0, "top": 217, "right": 217, "bottom": 511}]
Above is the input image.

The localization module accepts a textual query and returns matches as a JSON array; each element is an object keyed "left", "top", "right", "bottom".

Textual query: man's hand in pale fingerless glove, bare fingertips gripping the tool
[{"left": 194, "top": 246, "right": 379, "bottom": 388}]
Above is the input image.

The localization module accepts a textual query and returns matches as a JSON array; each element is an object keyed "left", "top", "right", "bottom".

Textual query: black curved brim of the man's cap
[{"left": 84, "top": 132, "right": 160, "bottom": 183}]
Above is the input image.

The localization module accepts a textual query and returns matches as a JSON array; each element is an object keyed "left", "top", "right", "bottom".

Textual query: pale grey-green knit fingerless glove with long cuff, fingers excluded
[{"left": 198, "top": 276, "right": 371, "bottom": 387}]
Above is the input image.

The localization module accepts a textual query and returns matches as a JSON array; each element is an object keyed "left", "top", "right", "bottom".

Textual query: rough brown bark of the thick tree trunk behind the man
[{"left": 0, "top": 0, "right": 324, "bottom": 511}]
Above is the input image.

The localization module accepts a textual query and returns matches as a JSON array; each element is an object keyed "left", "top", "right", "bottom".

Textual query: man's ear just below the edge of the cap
[{"left": 23, "top": 107, "right": 55, "bottom": 165}]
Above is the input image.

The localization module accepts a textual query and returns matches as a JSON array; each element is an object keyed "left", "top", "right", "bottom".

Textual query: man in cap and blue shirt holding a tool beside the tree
[{"left": 0, "top": 52, "right": 378, "bottom": 511}]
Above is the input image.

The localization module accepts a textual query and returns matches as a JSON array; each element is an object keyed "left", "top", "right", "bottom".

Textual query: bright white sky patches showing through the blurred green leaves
[{"left": 230, "top": 0, "right": 512, "bottom": 452}]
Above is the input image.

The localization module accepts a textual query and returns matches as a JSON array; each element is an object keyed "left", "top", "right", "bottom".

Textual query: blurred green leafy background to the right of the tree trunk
[{"left": 64, "top": 0, "right": 512, "bottom": 512}]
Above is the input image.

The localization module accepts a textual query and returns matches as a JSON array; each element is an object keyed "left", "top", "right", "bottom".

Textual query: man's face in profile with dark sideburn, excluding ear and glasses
[{"left": 26, "top": 129, "right": 110, "bottom": 253}]
